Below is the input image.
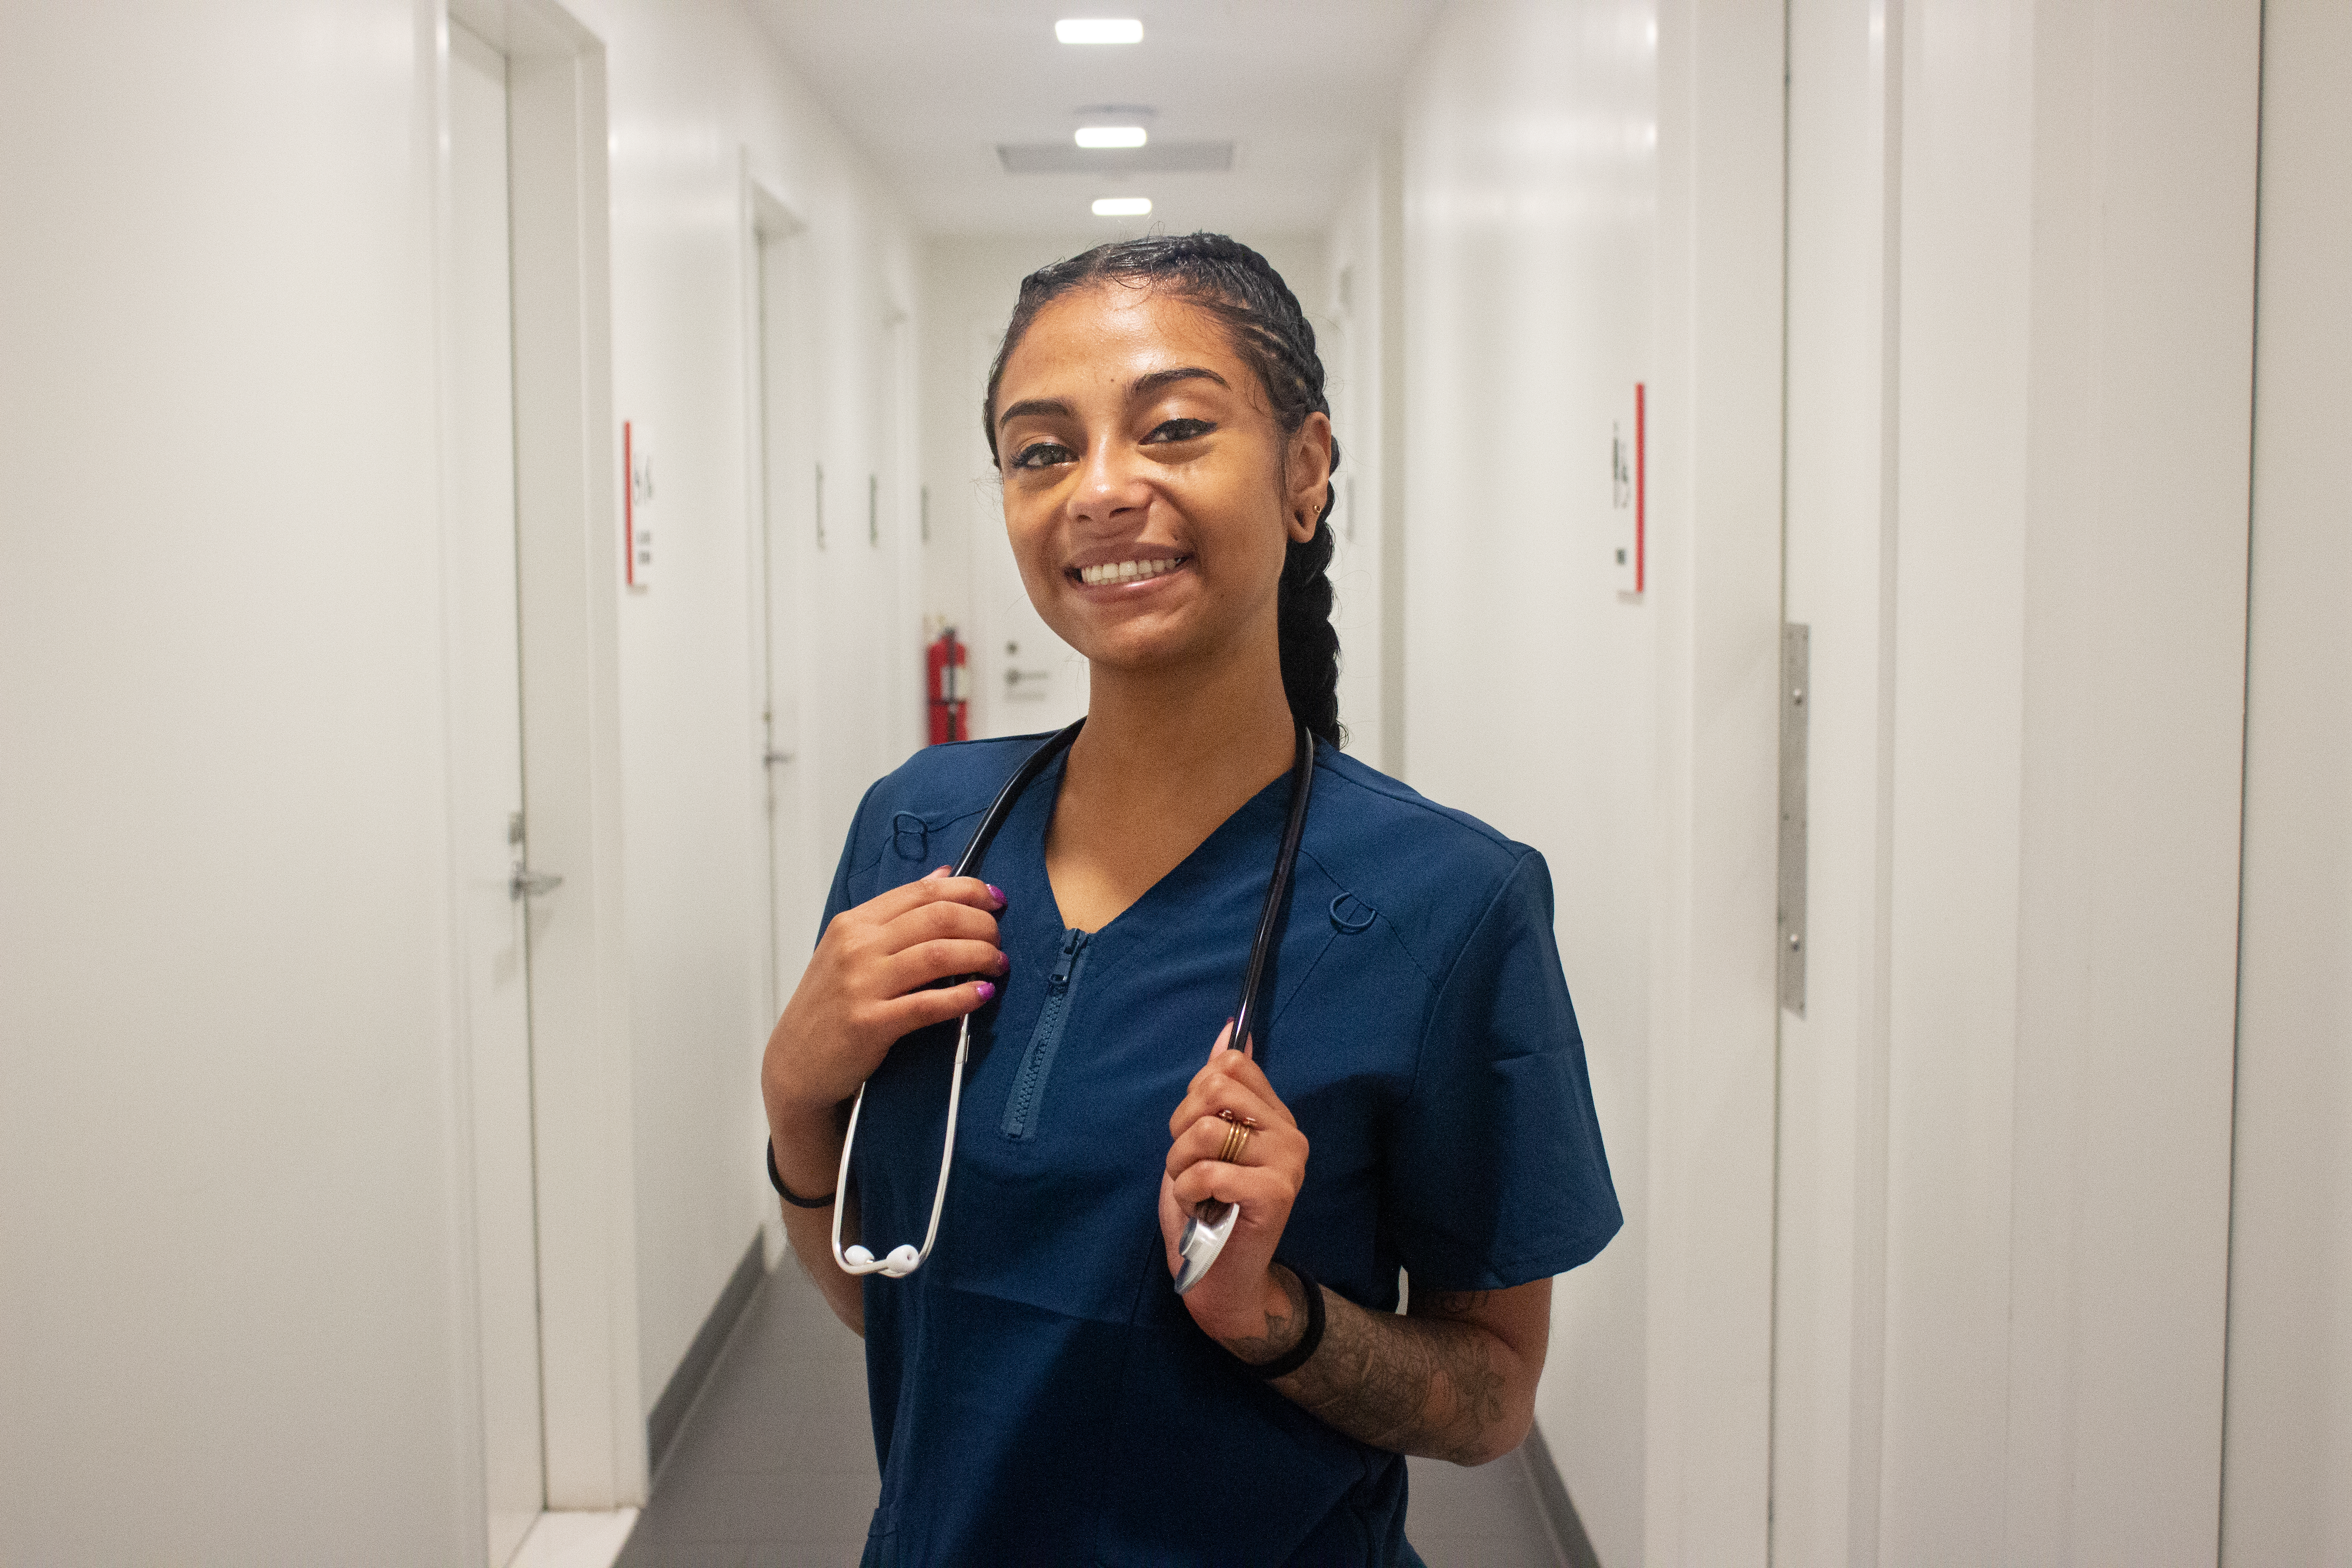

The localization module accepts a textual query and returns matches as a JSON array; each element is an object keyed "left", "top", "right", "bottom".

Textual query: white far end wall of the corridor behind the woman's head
[{"left": 920, "top": 223, "right": 1324, "bottom": 752}]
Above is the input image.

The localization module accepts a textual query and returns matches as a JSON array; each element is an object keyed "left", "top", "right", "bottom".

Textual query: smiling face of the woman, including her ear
[{"left": 995, "top": 282, "right": 1331, "bottom": 673}]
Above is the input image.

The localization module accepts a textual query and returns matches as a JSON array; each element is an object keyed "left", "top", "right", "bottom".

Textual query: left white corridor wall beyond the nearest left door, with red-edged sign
[{"left": 579, "top": 0, "right": 920, "bottom": 1406}]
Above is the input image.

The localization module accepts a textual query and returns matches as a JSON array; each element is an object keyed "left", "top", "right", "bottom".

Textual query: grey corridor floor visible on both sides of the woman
[{"left": 614, "top": 1260, "right": 1564, "bottom": 1568}]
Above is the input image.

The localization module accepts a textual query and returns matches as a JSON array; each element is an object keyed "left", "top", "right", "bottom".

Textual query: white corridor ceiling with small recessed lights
[{"left": 750, "top": 0, "right": 1444, "bottom": 238}]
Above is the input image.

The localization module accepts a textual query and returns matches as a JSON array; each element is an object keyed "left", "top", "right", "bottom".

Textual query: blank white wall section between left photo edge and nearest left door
[{"left": 0, "top": 0, "right": 480, "bottom": 1563}]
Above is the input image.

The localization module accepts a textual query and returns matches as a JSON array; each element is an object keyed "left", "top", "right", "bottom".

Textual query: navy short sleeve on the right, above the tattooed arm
[{"left": 1385, "top": 851, "right": 1623, "bottom": 1290}]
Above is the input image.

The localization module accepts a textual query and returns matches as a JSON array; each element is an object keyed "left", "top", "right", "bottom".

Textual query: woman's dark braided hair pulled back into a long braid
[{"left": 981, "top": 235, "right": 1348, "bottom": 748}]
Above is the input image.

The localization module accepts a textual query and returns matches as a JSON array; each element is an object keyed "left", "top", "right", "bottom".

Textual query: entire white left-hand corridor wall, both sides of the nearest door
[{"left": 0, "top": 0, "right": 917, "bottom": 1566}]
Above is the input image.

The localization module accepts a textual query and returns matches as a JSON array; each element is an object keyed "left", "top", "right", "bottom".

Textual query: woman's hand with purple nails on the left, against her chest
[{"left": 760, "top": 865, "right": 1011, "bottom": 1124}]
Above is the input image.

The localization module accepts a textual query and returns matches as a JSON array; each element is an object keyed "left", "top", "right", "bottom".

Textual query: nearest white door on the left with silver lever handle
[{"left": 449, "top": 24, "right": 546, "bottom": 1568}]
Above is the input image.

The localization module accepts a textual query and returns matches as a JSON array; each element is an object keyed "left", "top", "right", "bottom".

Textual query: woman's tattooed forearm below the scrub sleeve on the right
[{"left": 1232, "top": 1269, "right": 1510, "bottom": 1465}]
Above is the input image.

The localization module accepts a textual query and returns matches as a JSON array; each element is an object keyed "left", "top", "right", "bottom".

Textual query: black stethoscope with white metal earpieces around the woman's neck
[{"left": 833, "top": 720, "right": 1315, "bottom": 1295}]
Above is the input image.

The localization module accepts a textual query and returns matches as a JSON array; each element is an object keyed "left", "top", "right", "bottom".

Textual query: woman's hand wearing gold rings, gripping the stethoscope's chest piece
[{"left": 1160, "top": 1022, "right": 1308, "bottom": 1354}]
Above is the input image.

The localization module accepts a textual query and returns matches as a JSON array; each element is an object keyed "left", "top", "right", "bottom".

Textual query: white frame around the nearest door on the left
[{"left": 437, "top": 0, "right": 647, "bottom": 1514}]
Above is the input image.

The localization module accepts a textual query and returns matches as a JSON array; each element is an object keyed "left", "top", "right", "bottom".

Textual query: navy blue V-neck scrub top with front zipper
[{"left": 826, "top": 736, "right": 1621, "bottom": 1568}]
